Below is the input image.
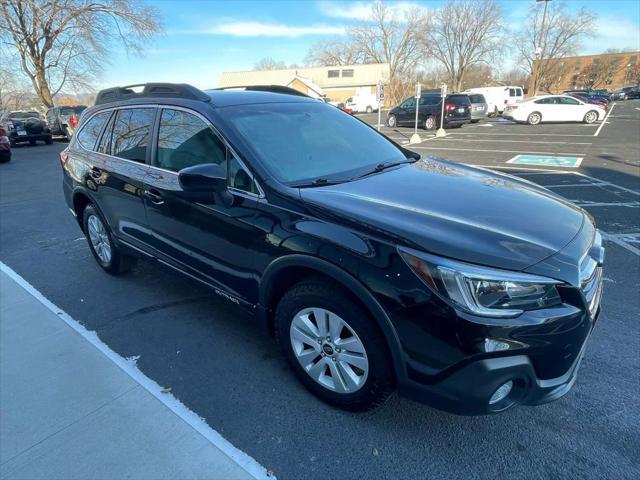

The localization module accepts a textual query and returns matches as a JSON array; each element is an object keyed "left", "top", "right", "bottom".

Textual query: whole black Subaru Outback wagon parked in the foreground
[{"left": 61, "top": 84, "right": 604, "bottom": 414}]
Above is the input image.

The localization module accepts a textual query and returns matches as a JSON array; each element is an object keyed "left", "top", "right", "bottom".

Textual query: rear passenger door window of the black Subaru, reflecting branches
[{"left": 111, "top": 108, "right": 156, "bottom": 163}]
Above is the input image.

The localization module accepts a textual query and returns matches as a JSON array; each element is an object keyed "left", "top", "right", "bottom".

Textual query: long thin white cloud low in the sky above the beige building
[{"left": 206, "top": 22, "right": 344, "bottom": 38}]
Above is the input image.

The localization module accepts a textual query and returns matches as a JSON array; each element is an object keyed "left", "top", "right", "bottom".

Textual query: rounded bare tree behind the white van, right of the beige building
[{"left": 425, "top": 0, "right": 503, "bottom": 91}]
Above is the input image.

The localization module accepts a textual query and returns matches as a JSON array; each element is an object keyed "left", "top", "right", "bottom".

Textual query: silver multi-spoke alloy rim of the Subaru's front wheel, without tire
[{"left": 289, "top": 308, "right": 369, "bottom": 394}]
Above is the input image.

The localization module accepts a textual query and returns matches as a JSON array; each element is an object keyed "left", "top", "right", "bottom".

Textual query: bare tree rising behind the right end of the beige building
[{"left": 307, "top": 2, "right": 431, "bottom": 103}]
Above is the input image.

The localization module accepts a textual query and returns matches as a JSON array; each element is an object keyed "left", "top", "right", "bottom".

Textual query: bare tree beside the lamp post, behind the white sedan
[{"left": 515, "top": 2, "right": 595, "bottom": 96}]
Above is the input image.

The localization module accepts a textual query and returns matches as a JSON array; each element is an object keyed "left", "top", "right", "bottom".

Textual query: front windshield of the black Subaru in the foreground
[{"left": 225, "top": 102, "right": 407, "bottom": 184}]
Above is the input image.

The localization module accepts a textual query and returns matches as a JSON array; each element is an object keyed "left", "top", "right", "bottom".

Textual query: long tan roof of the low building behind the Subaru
[{"left": 218, "top": 63, "right": 389, "bottom": 88}]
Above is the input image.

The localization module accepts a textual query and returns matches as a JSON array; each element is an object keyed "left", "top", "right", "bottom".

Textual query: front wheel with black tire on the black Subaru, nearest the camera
[{"left": 275, "top": 280, "right": 395, "bottom": 411}]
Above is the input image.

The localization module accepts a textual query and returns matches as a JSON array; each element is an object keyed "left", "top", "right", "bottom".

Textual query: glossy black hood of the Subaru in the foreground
[{"left": 300, "top": 158, "right": 585, "bottom": 270}]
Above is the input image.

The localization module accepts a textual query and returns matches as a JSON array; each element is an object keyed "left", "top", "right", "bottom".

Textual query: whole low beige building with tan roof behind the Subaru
[{"left": 218, "top": 63, "right": 389, "bottom": 101}]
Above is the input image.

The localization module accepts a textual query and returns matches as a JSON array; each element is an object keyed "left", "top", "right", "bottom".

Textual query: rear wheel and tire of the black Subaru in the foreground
[{"left": 82, "top": 205, "right": 134, "bottom": 275}]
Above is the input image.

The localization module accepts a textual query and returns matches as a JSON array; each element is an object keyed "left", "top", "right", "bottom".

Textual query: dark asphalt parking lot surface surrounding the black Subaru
[{"left": 0, "top": 100, "right": 640, "bottom": 479}]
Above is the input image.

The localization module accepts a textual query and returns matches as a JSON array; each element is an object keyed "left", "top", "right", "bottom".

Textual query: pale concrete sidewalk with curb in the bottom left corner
[{"left": 0, "top": 263, "right": 267, "bottom": 480}]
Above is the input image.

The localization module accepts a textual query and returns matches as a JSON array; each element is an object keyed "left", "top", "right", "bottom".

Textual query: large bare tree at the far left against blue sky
[{"left": 0, "top": 0, "right": 160, "bottom": 107}]
